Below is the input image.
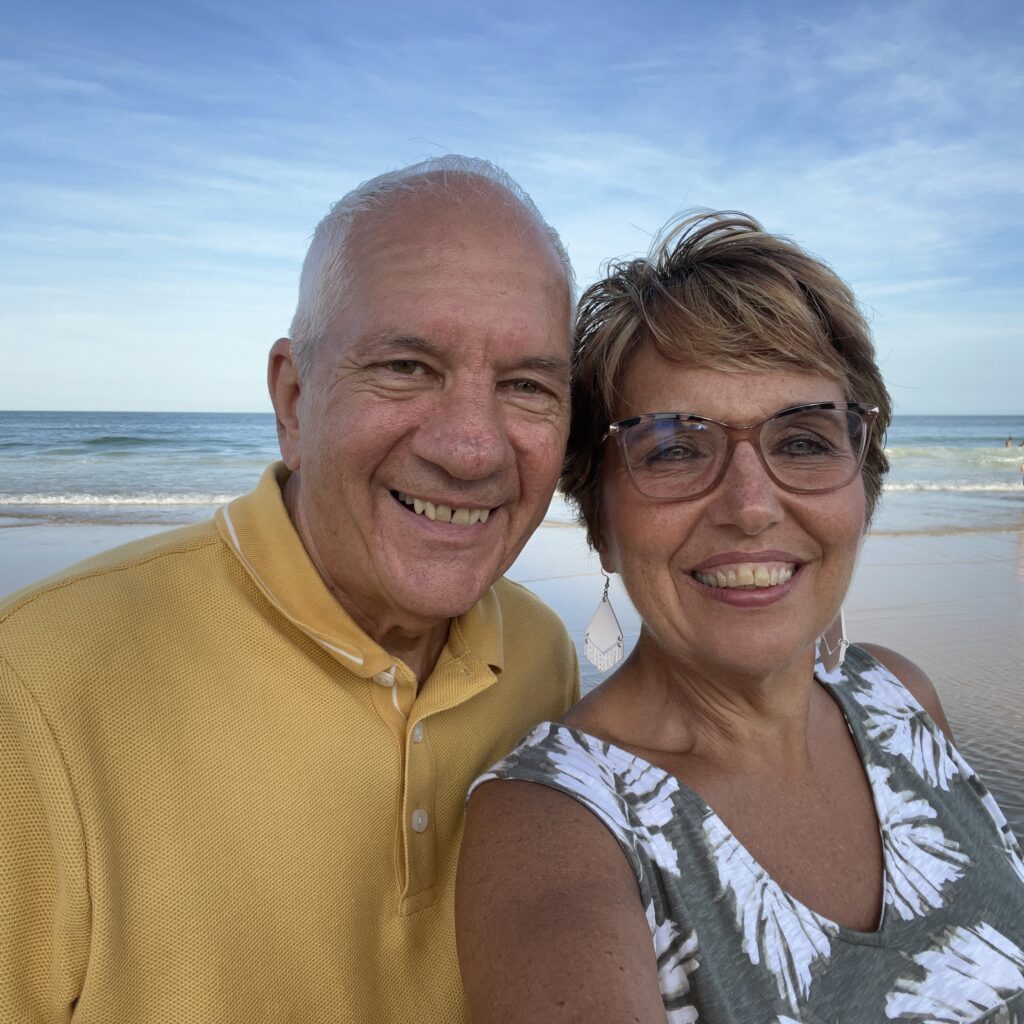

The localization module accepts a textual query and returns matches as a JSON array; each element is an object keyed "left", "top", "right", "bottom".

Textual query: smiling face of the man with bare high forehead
[{"left": 275, "top": 183, "right": 570, "bottom": 638}]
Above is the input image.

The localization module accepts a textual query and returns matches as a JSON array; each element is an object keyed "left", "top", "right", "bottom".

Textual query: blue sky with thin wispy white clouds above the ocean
[{"left": 0, "top": 0, "right": 1024, "bottom": 415}]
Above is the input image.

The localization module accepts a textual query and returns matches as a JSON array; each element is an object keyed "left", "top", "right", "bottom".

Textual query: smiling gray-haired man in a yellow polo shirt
[{"left": 0, "top": 158, "right": 578, "bottom": 1024}]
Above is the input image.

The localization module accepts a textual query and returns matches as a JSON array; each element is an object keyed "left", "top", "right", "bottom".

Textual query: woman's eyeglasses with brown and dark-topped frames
[{"left": 604, "top": 401, "right": 879, "bottom": 501}]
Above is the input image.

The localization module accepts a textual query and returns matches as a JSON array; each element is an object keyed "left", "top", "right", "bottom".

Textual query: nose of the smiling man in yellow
[{"left": 417, "top": 385, "right": 511, "bottom": 480}]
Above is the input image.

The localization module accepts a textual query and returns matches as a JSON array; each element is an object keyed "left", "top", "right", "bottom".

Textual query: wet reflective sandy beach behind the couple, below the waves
[{"left": 0, "top": 518, "right": 1024, "bottom": 834}]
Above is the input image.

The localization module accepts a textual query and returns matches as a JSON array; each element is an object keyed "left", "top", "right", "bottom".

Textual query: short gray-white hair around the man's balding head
[{"left": 289, "top": 154, "right": 577, "bottom": 378}]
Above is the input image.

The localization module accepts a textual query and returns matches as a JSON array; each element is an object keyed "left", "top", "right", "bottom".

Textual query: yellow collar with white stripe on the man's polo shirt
[{"left": 214, "top": 462, "right": 504, "bottom": 676}]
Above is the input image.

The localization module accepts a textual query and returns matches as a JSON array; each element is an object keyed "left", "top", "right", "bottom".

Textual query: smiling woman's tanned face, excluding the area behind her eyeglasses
[{"left": 601, "top": 347, "right": 865, "bottom": 675}]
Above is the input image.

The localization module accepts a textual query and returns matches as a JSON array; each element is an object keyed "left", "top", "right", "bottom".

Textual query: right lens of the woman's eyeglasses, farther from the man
[{"left": 761, "top": 409, "right": 867, "bottom": 490}]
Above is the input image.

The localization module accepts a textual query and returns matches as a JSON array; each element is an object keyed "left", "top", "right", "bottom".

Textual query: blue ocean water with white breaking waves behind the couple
[{"left": 0, "top": 412, "right": 1024, "bottom": 535}]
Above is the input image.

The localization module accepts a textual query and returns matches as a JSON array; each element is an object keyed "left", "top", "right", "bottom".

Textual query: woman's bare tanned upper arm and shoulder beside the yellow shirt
[{"left": 455, "top": 745, "right": 664, "bottom": 1021}]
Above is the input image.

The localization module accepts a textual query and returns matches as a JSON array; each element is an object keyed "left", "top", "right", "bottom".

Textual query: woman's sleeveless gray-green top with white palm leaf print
[{"left": 474, "top": 647, "right": 1024, "bottom": 1024}]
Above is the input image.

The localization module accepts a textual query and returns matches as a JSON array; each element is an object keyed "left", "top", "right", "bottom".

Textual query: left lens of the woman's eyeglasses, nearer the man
[{"left": 624, "top": 419, "right": 728, "bottom": 498}]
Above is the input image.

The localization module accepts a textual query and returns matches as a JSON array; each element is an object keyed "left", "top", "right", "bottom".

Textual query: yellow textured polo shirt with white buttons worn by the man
[{"left": 0, "top": 465, "right": 578, "bottom": 1024}]
